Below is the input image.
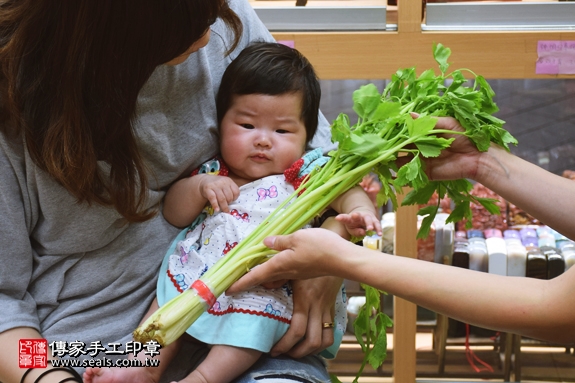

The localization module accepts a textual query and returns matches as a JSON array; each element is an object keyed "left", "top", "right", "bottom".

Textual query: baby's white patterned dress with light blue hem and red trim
[{"left": 157, "top": 152, "right": 347, "bottom": 358}]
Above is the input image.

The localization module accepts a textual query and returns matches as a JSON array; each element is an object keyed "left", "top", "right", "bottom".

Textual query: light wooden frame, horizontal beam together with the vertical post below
[{"left": 266, "top": 0, "right": 575, "bottom": 383}]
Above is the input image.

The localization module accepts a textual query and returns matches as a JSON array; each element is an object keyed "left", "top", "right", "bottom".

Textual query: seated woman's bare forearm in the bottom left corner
[{"left": 0, "top": 327, "right": 77, "bottom": 383}]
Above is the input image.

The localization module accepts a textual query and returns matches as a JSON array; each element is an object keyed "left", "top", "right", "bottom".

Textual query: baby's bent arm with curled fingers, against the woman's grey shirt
[{"left": 163, "top": 174, "right": 240, "bottom": 227}]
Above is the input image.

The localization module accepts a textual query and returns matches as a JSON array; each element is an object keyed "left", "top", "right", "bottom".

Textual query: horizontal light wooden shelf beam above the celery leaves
[{"left": 251, "top": 0, "right": 575, "bottom": 80}]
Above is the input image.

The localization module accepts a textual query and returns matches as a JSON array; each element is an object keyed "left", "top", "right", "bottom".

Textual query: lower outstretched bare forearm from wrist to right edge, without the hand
[{"left": 327, "top": 242, "right": 575, "bottom": 343}]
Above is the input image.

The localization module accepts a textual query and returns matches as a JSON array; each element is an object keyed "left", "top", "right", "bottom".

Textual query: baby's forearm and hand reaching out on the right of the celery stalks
[{"left": 331, "top": 186, "right": 382, "bottom": 237}]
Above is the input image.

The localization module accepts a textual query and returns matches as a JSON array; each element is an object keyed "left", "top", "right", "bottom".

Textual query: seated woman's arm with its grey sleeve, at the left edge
[{"left": 0, "top": 145, "right": 70, "bottom": 383}]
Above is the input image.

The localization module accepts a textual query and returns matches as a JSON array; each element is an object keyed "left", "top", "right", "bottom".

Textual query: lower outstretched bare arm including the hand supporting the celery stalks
[{"left": 230, "top": 229, "right": 575, "bottom": 343}]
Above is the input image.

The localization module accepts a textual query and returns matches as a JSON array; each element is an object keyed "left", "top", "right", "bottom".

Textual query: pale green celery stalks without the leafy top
[{"left": 134, "top": 134, "right": 411, "bottom": 346}]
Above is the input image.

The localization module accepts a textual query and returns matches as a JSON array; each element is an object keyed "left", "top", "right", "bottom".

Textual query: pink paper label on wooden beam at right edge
[{"left": 535, "top": 40, "right": 575, "bottom": 74}]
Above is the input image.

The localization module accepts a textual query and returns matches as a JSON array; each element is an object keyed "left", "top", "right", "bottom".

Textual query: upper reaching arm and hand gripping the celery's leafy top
[{"left": 420, "top": 117, "right": 575, "bottom": 239}]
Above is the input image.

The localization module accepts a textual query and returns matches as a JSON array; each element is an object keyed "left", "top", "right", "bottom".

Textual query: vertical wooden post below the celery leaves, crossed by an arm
[{"left": 393, "top": 189, "right": 418, "bottom": 383}]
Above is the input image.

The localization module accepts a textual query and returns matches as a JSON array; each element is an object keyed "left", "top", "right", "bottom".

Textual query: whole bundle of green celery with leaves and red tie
[{"left": 134, "top": 44, "right": 516, "bottom": 376}]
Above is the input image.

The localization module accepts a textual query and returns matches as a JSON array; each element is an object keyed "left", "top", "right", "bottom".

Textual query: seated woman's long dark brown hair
[{"left": 0, "top": 0, "right": 242, "bottom": 222}]
